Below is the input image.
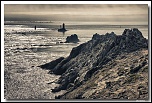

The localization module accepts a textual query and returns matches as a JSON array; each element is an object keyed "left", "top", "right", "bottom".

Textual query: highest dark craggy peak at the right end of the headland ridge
[{"left": 120, "top": 28, "right": 148, "bottom": 52}]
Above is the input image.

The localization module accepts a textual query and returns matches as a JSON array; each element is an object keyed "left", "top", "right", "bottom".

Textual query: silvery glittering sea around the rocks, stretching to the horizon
[{"left": 4, "top": 22, "right": 148, "bottom": 99}]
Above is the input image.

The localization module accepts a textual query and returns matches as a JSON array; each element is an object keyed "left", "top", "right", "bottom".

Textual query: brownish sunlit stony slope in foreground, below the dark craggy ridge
[{"left": 57, "top": 49, "right": 149, "bottom": 100}]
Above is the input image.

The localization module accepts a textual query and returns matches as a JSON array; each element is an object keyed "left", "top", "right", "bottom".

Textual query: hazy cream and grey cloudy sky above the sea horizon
[{"left": 4, "top": 4, "right": 148, "bottom": 25}]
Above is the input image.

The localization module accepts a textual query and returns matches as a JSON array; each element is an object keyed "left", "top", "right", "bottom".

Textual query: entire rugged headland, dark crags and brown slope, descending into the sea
[{"left": 40, "top": 28, "right": 148, "bottom": 99}]
